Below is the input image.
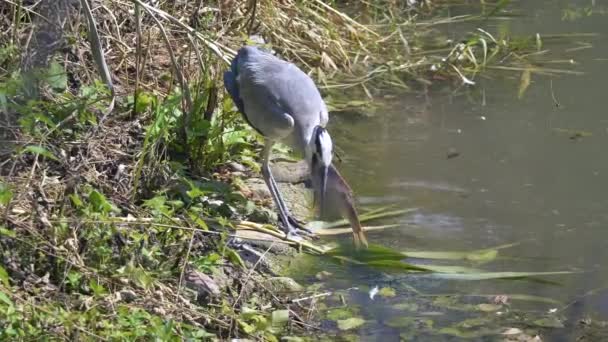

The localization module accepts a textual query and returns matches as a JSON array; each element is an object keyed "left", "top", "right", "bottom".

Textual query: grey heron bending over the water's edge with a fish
[{"left": 224, "top": 46, "right": 332, "bottom": 238}]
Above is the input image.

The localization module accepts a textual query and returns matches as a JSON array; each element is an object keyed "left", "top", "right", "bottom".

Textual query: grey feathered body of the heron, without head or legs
[{"left": 224, "top": 46, "right": 328, "bottom": 153}]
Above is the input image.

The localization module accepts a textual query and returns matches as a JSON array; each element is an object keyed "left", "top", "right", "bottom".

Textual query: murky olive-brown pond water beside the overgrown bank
[{"left": 292, "top": 0, "right": 608, "bottom": 341}]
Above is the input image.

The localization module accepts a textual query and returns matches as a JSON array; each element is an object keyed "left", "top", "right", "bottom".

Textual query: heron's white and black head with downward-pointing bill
[{"left": 308, "top": 126, "right": 333, "bottom": 212}]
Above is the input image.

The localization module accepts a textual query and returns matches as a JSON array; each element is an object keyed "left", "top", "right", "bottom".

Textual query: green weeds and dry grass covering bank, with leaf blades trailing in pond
[{"left": 0, "top": 0, "right": 600, "bottom": 340}]
